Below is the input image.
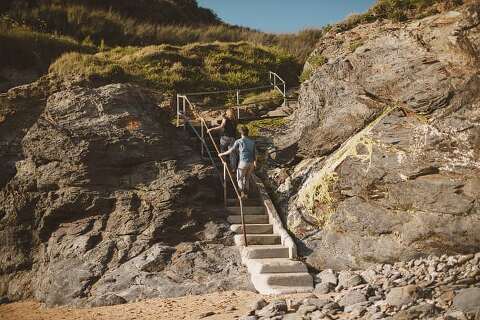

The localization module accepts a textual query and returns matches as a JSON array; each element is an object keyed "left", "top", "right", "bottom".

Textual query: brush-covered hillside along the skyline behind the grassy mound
[{"left": 0, "top": 0, "right": 322, "bottom": 63}]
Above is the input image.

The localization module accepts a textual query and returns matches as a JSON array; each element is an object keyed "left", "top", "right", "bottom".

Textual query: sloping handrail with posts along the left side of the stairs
[{"left": 177, "top": 95, "right": 248, "bottom": 247}]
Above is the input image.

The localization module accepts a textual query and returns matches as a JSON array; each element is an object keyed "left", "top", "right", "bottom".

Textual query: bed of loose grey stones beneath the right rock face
[{"left": 240, "top": 253, "right": 480, "bottom": 320}]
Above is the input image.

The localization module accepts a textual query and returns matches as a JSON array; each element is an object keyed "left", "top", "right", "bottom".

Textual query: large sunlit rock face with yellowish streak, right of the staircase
[{"left": 269, "top": 4, "right": 480, "bottom": 270}]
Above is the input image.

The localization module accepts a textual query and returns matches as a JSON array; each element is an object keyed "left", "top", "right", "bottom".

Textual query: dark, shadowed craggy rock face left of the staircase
[{"left": 0, "top": 84, "right": 249, "bottom": 306}]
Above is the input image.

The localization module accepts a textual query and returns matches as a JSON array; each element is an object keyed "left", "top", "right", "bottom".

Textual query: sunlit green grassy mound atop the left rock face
[{"left": 50, "top": 42, "right": 296, "bottom": 93}]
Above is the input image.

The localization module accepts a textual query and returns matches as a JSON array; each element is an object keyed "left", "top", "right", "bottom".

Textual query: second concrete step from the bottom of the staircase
[{"left": 247, "top": 258, "right": 308, "bottom": 274}]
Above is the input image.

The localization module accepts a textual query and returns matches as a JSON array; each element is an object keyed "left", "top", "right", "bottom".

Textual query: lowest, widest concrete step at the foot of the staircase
[{"left": 251, "top": 272, "right": 313, "bottom": 294}]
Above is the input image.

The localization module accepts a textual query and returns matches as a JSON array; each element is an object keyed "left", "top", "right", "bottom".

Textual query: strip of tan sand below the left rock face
[{"left": 0, "top": 291, "right": 312, "bottom": 320}]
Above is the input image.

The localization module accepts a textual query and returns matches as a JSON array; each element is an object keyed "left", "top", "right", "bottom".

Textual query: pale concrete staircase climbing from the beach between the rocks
[{"left": 227, "top": 181, "right": 313, "bottom": 294}]
